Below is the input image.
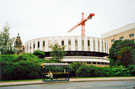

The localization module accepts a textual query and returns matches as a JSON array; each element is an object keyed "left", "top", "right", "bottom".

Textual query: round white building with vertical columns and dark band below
[{"left": 25, "top": 36, "right": 109, "bottom": 66}]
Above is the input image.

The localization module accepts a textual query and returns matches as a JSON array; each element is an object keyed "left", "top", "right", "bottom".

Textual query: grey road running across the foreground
[{"left": 0, "top": 80, "right": 135, "bottom": 89}]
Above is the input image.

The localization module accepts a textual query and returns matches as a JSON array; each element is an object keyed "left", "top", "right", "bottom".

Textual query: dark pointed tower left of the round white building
[{"left": 15, "top": 33, "right": 24, "bottom": 54}]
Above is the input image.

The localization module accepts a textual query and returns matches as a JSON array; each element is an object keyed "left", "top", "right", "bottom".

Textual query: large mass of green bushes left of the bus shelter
[{"left": 0, "top": 53, "right": 41, "bottom": 80}]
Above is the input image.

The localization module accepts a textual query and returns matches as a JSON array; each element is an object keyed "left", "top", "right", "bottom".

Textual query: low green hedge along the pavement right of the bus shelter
[{"left": 70, "top": 64, "right": 132, "bottom": 77}]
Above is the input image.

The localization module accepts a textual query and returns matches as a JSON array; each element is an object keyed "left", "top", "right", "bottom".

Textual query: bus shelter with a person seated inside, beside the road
[{"left": 41, "top": 63, "right": 70, "bottom": 82}]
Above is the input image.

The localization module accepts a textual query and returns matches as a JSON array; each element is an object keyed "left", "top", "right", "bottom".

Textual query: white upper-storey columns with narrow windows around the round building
[{"left": 25, "top": 36, "right": 108, "bottom": 53}]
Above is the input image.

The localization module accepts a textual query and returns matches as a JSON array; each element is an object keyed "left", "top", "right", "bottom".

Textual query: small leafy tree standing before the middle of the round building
[{"left": 50, "top": 44, "right": 66, "bottom": 62}]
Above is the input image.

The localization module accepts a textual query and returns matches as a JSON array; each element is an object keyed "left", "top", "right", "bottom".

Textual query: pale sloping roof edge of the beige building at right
[{"left": 101, "top": 22, "right": 135, "bottom": 38}]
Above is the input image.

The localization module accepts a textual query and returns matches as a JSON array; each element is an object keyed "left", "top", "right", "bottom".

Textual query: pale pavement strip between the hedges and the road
[{"left": 0, "top": 77, "right": 135, "bottom": 87}]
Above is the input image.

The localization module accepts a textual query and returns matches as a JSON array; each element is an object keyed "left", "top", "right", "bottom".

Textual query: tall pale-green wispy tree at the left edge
[{"left": 0, "top": 25, "right": 15, "bottom": 54}]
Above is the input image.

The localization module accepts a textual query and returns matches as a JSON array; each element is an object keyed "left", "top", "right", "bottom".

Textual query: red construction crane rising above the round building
[{"left": 68, "top": 12, "right": 95, "bottom": 36}]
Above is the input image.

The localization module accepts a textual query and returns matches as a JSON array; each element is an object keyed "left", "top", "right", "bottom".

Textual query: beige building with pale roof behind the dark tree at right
[{"left": 102, "top": 23, "right": 135, "bottom": 48}]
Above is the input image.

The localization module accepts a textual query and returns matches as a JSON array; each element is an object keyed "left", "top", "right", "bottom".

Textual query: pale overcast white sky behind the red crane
[{"left": 0, "top": 0, "right": 135, "bottom": 43}]
